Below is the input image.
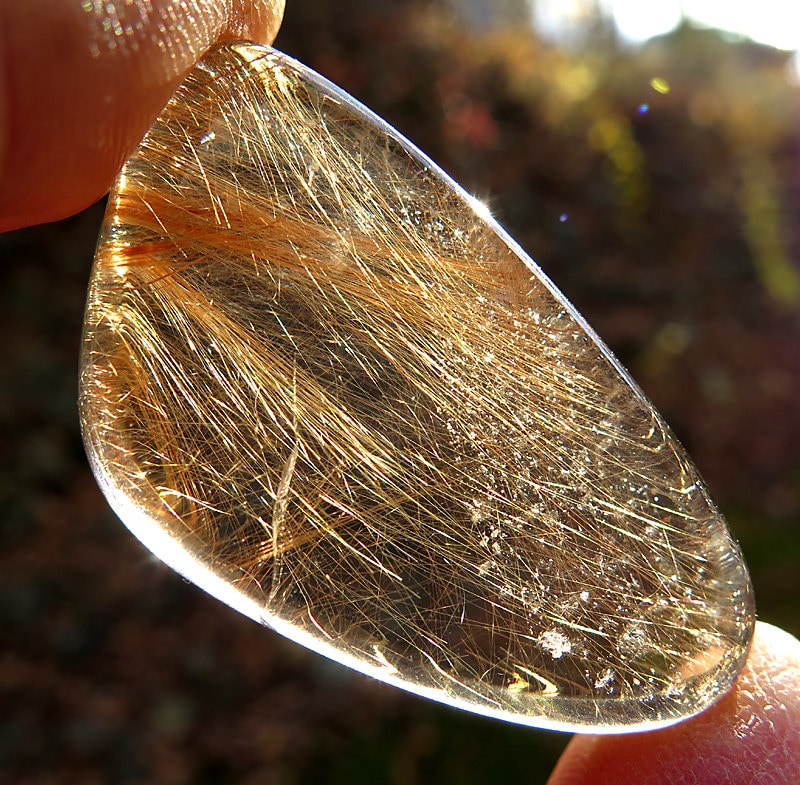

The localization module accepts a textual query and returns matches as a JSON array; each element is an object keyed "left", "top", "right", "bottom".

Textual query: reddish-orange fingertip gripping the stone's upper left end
[{"left": 0, "top": 0, "right": 283, "bottom": 231}]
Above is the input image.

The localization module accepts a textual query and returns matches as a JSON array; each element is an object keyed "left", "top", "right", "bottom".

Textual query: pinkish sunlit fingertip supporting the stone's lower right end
[{"left": 548, "top": 623, "right": 800, "bottom": 785}]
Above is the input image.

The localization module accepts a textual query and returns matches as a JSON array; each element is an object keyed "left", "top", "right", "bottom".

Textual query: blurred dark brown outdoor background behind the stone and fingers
[{"left": 0, "top": 0, "right": 800, "bottom": 785}]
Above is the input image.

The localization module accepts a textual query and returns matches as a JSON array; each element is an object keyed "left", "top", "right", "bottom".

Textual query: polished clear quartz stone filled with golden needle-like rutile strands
[{"left": 81, "top": 43, "right": 754, "bottom": 733}]
